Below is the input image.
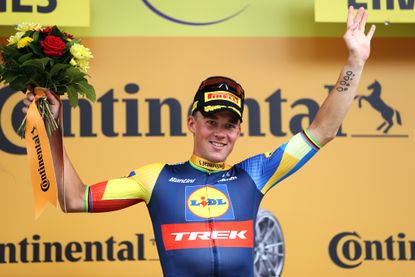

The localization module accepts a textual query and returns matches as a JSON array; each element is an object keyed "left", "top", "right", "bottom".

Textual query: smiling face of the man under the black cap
[{"left": 187, "top": 111, "right": 241, "bottom": 162}]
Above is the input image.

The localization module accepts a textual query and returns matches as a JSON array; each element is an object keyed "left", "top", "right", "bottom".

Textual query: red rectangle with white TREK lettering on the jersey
[{"left": 161, "top": 220, "right": 254, "bottom": 251}]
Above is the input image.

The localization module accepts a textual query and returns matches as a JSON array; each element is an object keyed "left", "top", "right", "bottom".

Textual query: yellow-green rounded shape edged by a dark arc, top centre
[{"left": 143, "top": 0, "right": 248, "bottom": 26}]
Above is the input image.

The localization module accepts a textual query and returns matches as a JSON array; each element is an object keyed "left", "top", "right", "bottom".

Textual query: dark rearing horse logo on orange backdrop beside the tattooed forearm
[{"left": 354, "top": 81, "right": 402, "bottom": 134}]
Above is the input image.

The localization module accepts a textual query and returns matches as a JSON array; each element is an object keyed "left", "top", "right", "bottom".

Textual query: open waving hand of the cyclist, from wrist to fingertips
[{"left": 343, "top": 6, "right": 376, "bottom": 64}]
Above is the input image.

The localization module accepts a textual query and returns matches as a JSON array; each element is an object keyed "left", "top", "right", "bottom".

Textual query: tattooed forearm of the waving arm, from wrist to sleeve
[{"left": 308, "top": 59, "right": 364, "bottom": 145}]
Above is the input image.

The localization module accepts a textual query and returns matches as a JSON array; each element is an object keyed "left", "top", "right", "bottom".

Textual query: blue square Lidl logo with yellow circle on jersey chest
[{"left": 185, "top": 184, "right": 235, "bottom": 221}]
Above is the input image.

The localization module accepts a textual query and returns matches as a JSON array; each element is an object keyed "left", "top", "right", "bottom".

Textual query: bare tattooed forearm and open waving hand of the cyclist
[{"left": 308, "top": 7, "right": 375, "bottom": 145}]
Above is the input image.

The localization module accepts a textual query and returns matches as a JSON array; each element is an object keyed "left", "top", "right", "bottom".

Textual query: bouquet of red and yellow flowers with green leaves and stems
[{"left": 0, "top": 23, "right": 96, "bottom": 136}]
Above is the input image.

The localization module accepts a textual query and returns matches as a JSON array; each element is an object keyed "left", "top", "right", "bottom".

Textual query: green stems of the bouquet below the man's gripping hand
[{"left": 17, "top": 87, "right": 59, "bottom": 138}]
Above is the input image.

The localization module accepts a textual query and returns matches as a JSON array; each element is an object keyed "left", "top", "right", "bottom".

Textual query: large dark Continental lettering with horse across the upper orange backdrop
[{"left": 0, "top": 80, "right": 409, "bottom": 155}]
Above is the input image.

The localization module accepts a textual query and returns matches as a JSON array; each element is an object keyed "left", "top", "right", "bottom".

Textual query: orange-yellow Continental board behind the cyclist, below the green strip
[{"left": 0, "top": 37, "right": 415, "bottom": 277}]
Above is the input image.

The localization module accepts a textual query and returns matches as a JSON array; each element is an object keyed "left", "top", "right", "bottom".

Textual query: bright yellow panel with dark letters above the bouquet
[{"left": 0, "top": 0, "right": 90, "bottom": 27}]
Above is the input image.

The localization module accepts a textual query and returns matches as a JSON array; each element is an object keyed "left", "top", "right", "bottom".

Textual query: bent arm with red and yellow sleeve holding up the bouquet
[{"left": 23, "top": 91, "right": 158, "bottom": 212}]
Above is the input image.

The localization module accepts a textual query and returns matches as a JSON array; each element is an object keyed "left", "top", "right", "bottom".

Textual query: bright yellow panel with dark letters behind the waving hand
[{"left": 314, "top": 0, "right": 415, "bottom": 24}]
